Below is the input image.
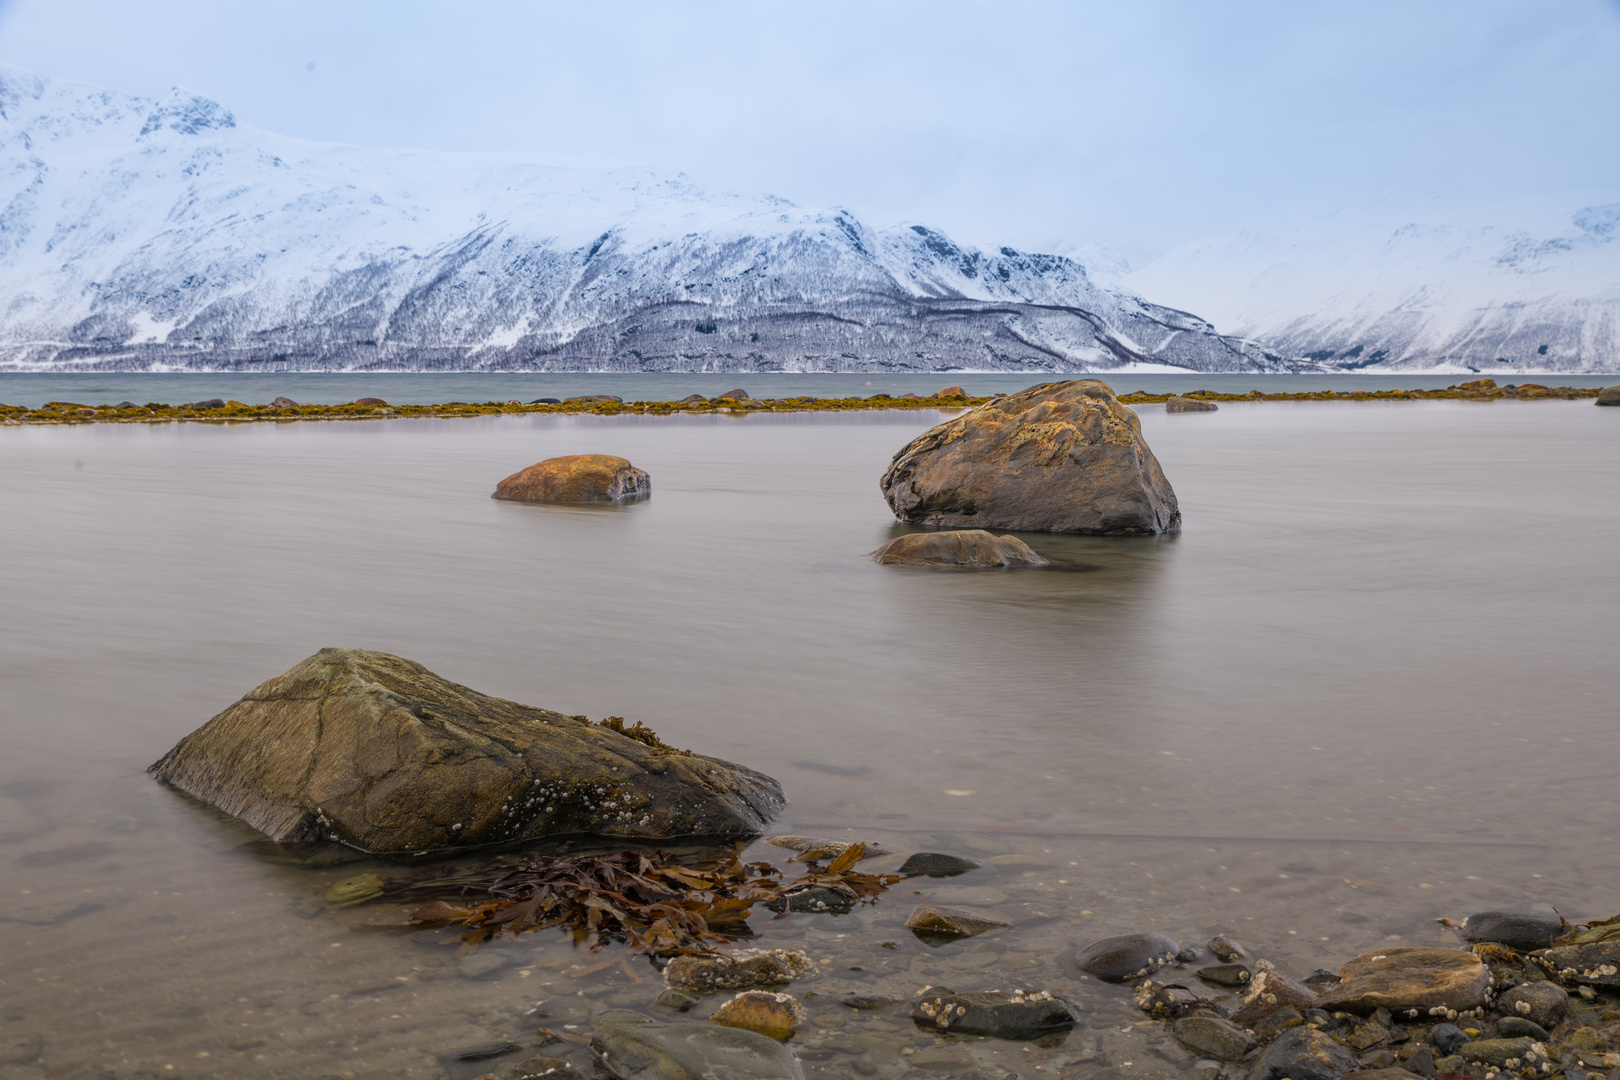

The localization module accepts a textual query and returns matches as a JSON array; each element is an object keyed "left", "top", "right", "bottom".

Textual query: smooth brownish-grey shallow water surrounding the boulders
[{"left": 0, "top": 402, "right": 1620, "bottom": 1077}]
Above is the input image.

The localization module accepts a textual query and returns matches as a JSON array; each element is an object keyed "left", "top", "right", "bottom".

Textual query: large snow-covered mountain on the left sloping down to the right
[{"left": 0, "top": 68, "right": 1298, "bottom": 372}]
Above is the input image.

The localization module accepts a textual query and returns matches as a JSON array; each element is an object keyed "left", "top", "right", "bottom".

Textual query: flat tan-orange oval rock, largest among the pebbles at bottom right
[{"left": 1315, "top": 947, "right": 1490, "bottom": 1016}]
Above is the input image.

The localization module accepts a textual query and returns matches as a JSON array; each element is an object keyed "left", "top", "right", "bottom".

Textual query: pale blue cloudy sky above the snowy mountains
[{"left": 0, "top": 0, "right": 1620, "bottom": 257}]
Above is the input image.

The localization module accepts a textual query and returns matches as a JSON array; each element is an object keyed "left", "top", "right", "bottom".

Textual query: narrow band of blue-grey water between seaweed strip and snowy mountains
[{"left": 0, "top": 371, "right": 1620, "bottom": 408}]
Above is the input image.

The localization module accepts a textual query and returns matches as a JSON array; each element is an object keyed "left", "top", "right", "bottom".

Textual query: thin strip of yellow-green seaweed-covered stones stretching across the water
[{"left": 0, "top": 379, "right": 1601, "bottom": 424}]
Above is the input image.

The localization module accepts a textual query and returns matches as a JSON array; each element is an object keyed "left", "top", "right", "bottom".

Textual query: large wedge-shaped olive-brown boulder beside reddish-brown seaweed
[{"left": 149, "top": 649, "right": 786, "bottom": 853}]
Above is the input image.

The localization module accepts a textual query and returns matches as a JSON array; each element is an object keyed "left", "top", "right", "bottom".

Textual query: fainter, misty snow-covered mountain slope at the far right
[{"left": 1123, "top": 200, "right": 1620, "bottom": 374}]
